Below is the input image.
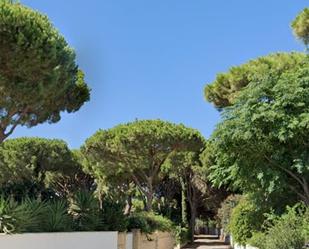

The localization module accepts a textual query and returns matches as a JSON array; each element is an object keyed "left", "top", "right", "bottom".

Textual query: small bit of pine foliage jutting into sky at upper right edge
[{"left": 291, "top": 8, "right": 309, "bottom": 46}]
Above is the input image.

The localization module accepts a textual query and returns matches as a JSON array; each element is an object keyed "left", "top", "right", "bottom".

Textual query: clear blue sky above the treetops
[{"left": 12, "top": 0, "right": 309, "bottom": 148}]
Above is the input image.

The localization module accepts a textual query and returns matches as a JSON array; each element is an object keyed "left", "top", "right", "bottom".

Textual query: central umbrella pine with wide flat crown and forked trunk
[{"left": 82, "top": 120, "right": 204, "bottom": 210}]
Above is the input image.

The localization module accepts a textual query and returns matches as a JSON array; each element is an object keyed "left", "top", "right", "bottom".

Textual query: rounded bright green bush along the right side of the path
[{"left": 228, "top": 199, "right": 264, "bottom": 245}]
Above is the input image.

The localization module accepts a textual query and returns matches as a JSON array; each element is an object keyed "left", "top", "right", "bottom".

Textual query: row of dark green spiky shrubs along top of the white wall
[{"left": 0, "top": 192, "right": 126, "bottom": 234}]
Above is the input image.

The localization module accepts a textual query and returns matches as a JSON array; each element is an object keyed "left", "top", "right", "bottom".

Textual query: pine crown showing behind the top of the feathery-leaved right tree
[{"left": 205, "top": 53, "right": 305, "bottom": 108}]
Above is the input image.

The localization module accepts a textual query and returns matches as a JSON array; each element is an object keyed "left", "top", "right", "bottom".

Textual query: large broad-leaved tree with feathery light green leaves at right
[{"left": 204, "top": 58, "right": 309, "bottom": 205}]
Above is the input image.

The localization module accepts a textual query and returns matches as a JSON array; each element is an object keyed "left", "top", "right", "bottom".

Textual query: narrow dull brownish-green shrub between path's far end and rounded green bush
[{"left": 217, "top": 195, "right": 241, "bottom": 233}]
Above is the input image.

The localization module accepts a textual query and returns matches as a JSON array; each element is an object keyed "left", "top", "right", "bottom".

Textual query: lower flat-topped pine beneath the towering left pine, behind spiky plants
[{"left": 0, "top": 138, "right": 81, "bottom": 196}]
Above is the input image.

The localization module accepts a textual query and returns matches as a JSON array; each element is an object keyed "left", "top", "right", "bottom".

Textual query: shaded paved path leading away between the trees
[{"left": 184, "top": 235, "right": 231, "bottom": 249}]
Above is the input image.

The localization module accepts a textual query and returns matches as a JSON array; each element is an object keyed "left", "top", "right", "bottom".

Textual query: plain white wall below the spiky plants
[{"left": 0, "top": 232, "right": 118, "bottom": 249}]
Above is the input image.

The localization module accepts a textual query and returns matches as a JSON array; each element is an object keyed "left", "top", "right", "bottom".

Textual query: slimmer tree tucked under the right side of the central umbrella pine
[{"left": 164, "top": 151, "right": 227, "bottom": 241}]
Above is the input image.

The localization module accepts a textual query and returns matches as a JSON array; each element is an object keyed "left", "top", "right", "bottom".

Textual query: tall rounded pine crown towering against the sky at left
[{"left": 0, "top": 0, "right": 89, "bottom": 143}]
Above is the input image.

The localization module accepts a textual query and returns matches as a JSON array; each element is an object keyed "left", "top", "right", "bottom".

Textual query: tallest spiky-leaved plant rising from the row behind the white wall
[{"left": 69, "top": 191, "right": 101, "bottom": 231}]
